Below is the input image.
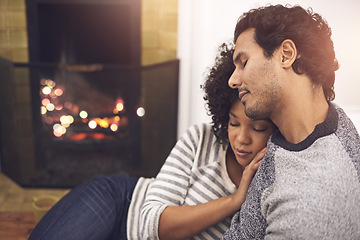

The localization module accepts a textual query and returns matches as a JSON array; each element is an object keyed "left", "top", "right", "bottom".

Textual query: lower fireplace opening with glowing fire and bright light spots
[{"left": 30, "top": 64, "right": 146, "bottom": 185}]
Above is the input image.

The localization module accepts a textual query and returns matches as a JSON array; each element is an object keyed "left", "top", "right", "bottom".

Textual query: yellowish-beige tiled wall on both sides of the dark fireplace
[{"left": 0, "top": 0, "right": 178, "bottom": 66}]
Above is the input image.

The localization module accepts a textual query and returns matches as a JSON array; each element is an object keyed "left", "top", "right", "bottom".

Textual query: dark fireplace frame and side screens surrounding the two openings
[{"left": 0, "top": 0, "right": 179, "bottom": 187}]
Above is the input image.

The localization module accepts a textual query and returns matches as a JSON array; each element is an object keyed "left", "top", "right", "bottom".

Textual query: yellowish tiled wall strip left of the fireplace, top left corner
[{"left": 0, "top": 0, "right": 29, "bottom": 62}]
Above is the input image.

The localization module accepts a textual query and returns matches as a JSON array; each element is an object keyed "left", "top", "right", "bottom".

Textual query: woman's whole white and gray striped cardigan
[{"left": 127, "top": 124, "right": 236, "bottom": 239}]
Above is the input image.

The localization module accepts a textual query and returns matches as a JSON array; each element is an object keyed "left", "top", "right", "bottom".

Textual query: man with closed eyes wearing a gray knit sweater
[{"left": 223, "top": 5, "right": 360, "bottom": 239}]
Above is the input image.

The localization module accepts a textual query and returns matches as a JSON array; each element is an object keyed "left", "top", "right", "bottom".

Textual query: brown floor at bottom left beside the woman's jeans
[{"left": 0, "top": 172, "right": 69, "bottom": 240}]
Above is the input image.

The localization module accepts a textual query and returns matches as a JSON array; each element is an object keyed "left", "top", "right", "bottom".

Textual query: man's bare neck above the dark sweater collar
[{"left": 272, "top": 86, "right": 329, "bottom": 144}]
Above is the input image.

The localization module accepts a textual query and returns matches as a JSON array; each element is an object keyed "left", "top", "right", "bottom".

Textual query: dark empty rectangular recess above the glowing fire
[{"left": 37, "top": 1, "right": 133, "bottom": 65}]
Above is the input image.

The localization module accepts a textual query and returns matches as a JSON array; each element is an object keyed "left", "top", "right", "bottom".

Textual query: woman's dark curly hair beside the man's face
[{"left": 202, "top": 43, "right": 239, "bottom": 143}]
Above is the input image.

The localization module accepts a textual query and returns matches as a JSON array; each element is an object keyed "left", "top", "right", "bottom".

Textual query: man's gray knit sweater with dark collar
[{"left": 223, "top": 104, "right": 360, "bottom": 239}]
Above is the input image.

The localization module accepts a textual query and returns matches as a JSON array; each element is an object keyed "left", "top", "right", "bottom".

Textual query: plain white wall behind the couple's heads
[{"left": 178, "top": 0, "right": 360, "bottom": 136}]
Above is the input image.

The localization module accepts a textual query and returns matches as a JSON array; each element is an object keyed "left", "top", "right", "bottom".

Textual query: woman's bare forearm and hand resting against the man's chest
[{"left": 159, "top": 149, "right": 266, "bottom": 240}]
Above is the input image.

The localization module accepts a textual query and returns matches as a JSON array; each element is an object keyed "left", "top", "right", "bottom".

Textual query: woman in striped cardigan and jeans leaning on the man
[{"left": 29, "top": 42, "right": 275, "bottom": 240}]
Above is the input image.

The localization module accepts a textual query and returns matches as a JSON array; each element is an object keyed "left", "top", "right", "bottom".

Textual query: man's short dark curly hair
[{"left": 234, "top": 5, "right": 339, "bottom": 101}]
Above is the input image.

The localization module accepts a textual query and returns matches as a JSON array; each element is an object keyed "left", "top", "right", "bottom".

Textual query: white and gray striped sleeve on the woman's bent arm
[{"left": 140, "top": 125, "right": 204, "bottom": 239}]
